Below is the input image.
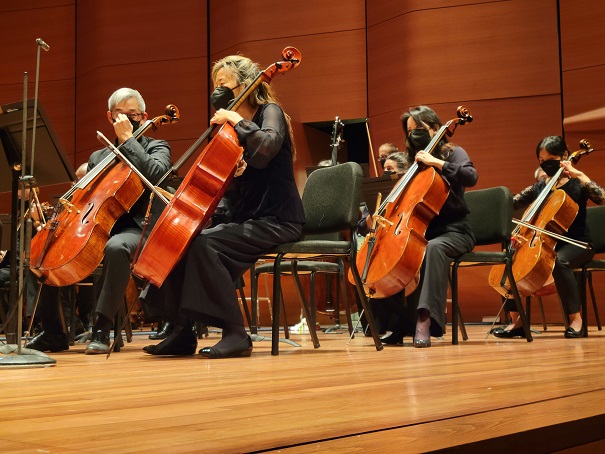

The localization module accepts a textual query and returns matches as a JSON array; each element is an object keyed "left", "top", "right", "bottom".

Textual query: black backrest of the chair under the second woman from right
[{"left": 464, "top": 186, "right": 513, "bottom": 246}]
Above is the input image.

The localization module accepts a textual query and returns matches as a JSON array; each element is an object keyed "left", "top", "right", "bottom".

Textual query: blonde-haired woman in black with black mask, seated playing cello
[{"left": 144, "top": 55, "right": 304, "bottom": 358}]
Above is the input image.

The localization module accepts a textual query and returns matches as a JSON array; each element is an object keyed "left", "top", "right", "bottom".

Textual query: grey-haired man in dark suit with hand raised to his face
[{"left": 27, "top": 88, "right": 171, "bottom": 354}]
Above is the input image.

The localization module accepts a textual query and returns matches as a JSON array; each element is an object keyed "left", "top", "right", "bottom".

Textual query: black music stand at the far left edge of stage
[{"left": 0, "top": 99, "right": 76, "bottom": 367}]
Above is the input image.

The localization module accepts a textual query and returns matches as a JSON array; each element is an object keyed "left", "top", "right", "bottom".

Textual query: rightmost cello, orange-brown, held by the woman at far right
[{"left": 488, "top": 139, "right": 593, "bottom": 298}]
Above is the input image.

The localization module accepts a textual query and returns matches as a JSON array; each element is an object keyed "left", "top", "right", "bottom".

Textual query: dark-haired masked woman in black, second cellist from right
[{"left": 382, "top": 106, "right": 477, "bottom": 347}]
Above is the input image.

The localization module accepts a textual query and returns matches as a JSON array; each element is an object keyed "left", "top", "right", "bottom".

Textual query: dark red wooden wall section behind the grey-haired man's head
[{"left": 76, "top": 0, "right": 208, "bottom": 170}]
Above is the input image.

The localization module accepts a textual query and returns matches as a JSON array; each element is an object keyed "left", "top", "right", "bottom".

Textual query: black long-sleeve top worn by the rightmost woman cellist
[{"left": 513, "top": 178, "right": 605, "bottom": 243}]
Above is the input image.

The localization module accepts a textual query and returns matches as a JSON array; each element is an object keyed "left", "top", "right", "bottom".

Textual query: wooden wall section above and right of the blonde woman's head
[{"left": 210, "top": 0, "right": 367, "bottom": 123}]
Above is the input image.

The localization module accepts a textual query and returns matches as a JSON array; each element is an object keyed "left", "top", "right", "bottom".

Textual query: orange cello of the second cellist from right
[{"left": 349, "top": 106, "right": 473, "bottom": 298}]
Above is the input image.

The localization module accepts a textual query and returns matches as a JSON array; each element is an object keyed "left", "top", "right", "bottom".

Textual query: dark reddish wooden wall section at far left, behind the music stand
[{"left": 0, "top": 0, "right": 75, "bottom": 213}]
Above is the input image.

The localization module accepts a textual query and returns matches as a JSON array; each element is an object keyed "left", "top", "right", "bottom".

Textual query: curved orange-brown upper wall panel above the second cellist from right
[{"left": 368, "top": 0, "right": 560, "bottom": 117}]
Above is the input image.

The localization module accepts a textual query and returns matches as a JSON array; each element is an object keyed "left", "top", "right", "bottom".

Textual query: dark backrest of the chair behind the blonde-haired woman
[{"left": 302, "top": 162, "right": 363, "bottom": 235}]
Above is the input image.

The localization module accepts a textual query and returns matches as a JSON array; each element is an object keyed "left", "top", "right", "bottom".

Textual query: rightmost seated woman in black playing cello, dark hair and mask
[{"left": 493, "top": 136, "right": 605, "bottom": 338}]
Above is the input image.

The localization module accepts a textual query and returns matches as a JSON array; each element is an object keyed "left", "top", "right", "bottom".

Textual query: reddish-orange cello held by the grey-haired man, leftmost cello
[{"left": 30, "top": 104, "right": 179, "bottom": 287}]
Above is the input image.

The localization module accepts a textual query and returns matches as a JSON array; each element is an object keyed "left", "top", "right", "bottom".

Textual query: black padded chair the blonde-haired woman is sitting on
[{"left": 261, "top": 162, "right": 383, "bottom": 355}]
